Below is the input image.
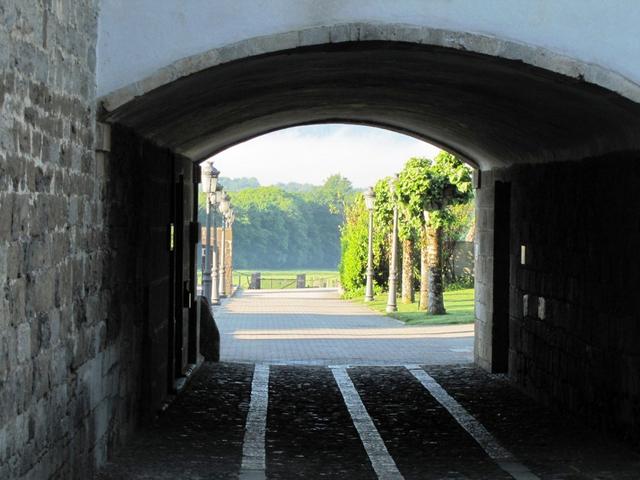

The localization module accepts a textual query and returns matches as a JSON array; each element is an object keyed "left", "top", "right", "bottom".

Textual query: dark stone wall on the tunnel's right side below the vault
[{"left": 476, "top": 153, "right": 640, "bottom": 440}]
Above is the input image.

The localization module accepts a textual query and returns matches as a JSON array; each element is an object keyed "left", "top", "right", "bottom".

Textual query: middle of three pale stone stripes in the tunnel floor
[{"left": 331, "top": 366, "right": 403, "bottom": 480}]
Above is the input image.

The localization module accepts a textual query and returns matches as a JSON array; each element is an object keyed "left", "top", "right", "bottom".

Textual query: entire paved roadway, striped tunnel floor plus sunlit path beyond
[{"left": 98, "top": 290, "right": 640, "bottom": 480}]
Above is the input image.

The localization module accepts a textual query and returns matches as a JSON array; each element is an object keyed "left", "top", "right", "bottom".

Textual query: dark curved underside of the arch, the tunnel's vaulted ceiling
[{"left": 103, "top": 41, "right": 640, "bottom": 169}]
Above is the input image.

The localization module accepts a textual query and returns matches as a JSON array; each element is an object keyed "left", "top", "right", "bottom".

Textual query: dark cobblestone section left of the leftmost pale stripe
[{"left": 97, "top": 363, "right": 253, "bottom": 480}]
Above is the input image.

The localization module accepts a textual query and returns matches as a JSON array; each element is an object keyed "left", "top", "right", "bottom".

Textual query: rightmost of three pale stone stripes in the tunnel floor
[{"left": 405, "top": 365, "right": 539, "bottom": 480}]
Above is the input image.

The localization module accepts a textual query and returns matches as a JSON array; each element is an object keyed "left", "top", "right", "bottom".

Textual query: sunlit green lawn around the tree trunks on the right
[{"left": 353, "top": 288, "right": 474, "bottom": 325}]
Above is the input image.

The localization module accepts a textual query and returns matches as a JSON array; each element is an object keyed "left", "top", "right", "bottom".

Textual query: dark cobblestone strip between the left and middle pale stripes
[{"left": 266, "top": 366, "right": 376, "bottom": 479}]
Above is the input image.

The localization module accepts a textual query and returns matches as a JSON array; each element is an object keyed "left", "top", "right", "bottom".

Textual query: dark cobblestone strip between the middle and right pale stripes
[{"left": 349, "top": 367, "right": 510, "bottom": 480}]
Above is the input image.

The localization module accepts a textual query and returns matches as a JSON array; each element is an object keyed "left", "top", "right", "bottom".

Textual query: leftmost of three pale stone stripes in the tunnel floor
[{"left": 240, "top": 364, "right": 269, "bottom": 480}]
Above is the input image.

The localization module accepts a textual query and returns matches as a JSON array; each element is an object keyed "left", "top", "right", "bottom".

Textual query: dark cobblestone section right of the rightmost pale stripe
[{"left": 425, "top": 366, "right": 640, "bottom": 480}]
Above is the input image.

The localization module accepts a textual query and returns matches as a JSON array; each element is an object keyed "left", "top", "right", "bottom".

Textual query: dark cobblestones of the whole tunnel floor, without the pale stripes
[{"left": 98, "top": 363, "right": 640, "bottom": 480}]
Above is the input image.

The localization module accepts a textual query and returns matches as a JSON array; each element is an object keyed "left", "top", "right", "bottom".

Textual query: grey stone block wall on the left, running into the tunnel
[{"left": 0, "top": 0, "right": 150, "bottom": 479}]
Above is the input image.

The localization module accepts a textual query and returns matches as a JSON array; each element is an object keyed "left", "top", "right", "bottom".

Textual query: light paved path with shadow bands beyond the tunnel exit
[{"left": 214, "top": 289, "right": 473, "bottom": 365}]
